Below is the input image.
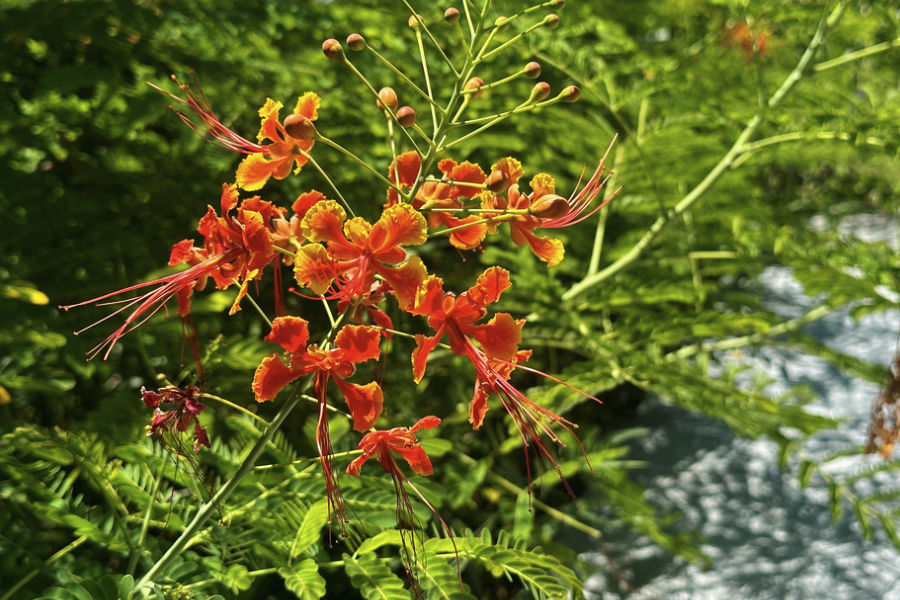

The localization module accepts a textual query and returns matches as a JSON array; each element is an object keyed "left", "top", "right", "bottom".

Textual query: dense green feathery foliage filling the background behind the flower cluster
[{"left": 0, "top": 0, "right": 900, "bottom": 600}]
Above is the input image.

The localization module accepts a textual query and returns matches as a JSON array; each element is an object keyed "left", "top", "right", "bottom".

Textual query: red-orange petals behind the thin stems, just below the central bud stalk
[{"left": 388, "top": 152, "right": 487, "bottom": 250}]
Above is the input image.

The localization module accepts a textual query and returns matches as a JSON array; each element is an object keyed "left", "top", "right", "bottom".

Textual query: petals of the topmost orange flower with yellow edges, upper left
[{"left": 237, "top": 92, "right": 321, "bottom": 191}]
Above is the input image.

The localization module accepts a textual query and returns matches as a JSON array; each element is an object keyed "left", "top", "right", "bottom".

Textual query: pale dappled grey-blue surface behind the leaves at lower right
[{"left": 583, "top": 215, "right": 900, "bottom": 600}]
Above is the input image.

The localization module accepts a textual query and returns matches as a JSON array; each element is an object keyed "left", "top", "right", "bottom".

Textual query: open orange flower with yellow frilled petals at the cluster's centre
[{"left": 294, "top": 200, "right": 427, "bottom": 307}]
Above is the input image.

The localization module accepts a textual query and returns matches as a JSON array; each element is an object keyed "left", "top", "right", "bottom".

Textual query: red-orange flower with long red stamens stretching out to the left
[{"left": 60, "top": 184, "right": 283, "bottom": 359}]
